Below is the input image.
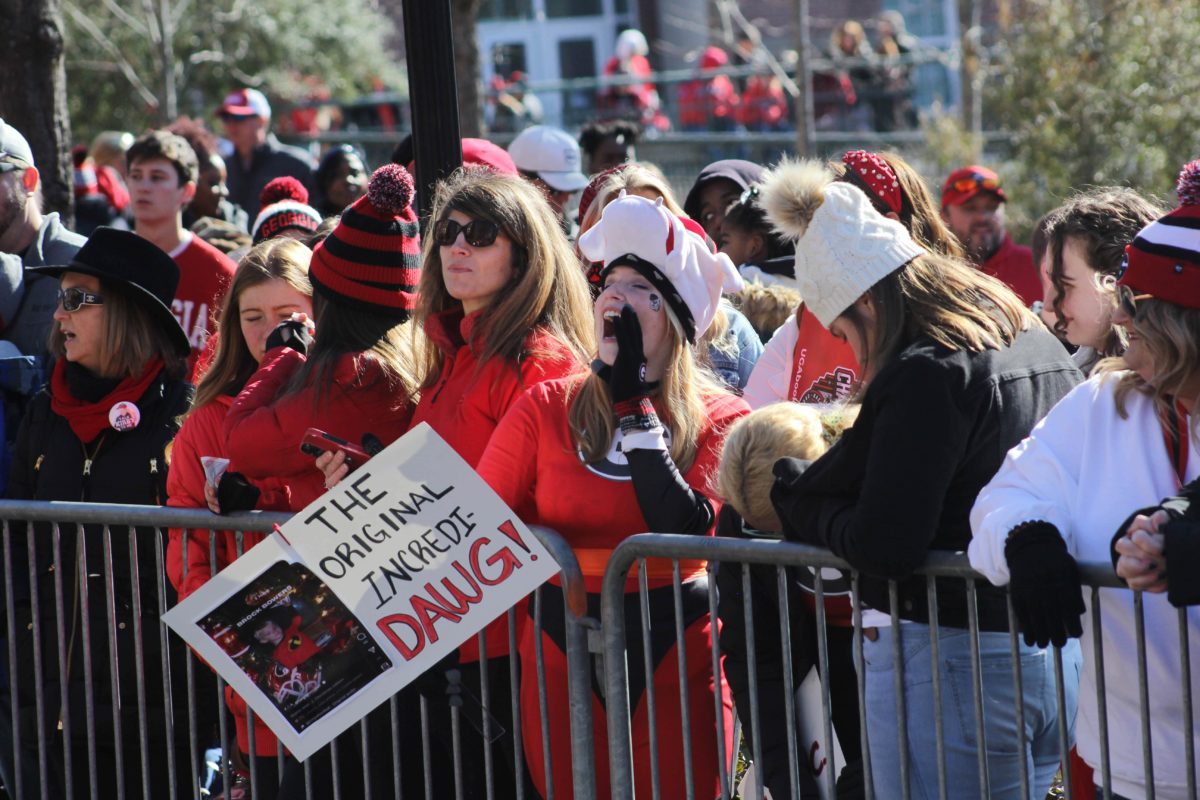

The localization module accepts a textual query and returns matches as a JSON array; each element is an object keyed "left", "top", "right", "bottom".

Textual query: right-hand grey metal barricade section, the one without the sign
[{"left": 601, "top": 534, "right": 1200, "bottom": 800}]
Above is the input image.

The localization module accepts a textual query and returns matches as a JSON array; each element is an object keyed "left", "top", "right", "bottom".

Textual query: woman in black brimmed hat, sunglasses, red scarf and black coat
[{"left": 5, "top": 228, "right": 191, "bottom": 796}]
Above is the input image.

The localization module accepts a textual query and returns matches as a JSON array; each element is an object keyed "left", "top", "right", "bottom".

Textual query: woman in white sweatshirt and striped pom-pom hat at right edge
[{"left": 967, "top": 161, "right": 1200, "bottom": 798}]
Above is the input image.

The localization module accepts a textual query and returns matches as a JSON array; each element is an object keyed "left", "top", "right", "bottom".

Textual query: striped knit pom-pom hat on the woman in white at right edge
[{"left": 1118, "top": 160, "right": 1200, "bottom": 308}]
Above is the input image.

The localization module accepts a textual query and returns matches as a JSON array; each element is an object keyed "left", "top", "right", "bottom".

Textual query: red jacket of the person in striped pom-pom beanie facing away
[{"left": 224, "top": 347, "right": 413, "bottom": 511}]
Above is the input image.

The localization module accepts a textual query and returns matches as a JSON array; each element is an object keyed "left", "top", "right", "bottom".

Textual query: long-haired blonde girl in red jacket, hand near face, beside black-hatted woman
[{"left": 167, "top": 239, "right": 312, "bottom": 796}]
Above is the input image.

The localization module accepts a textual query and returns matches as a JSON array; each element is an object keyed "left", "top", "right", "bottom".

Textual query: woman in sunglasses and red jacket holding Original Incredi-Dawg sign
[{"left": 323, "top": 168, "right": 593, "bottom": 798}]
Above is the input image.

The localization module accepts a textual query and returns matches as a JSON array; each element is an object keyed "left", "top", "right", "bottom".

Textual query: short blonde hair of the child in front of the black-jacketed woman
[{"left": 714, "top": 403, "right": 858, "bottom": 531}]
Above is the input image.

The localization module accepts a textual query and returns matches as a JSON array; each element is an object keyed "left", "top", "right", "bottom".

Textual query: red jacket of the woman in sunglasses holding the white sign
[{"left": 413, "top": 308, "right": 582, "bottom": 662}]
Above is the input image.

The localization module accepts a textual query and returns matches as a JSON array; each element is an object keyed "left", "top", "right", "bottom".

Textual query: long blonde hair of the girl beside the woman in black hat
[{"left": 192, "top": 239, "right": 312, "bottom": 410}]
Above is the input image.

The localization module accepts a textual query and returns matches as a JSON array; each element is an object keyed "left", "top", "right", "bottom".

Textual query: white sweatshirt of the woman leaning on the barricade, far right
[{"left": 967, "top": 374, "right": 1200, "bottom": 800}]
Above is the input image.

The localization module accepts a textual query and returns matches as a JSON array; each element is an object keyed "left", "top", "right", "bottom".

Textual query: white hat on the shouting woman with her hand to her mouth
[{"left": 580, "top": 192, "right": 744, "bottom": 344}]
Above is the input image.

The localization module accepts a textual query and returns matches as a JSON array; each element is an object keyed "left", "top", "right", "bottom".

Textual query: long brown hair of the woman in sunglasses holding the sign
[{"left": 415, "top": 168, "right": 595, "bottom": 387}]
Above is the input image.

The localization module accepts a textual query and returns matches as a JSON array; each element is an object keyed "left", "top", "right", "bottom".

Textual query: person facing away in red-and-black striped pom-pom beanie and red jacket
[{"left": 224, "top": 164, "right": 420, "bottom": 511}]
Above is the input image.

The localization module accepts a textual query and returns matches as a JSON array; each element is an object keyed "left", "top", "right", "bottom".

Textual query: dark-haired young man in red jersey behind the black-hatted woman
[{"left": 125, "top": 131, "right": 236, "bottom": 381}]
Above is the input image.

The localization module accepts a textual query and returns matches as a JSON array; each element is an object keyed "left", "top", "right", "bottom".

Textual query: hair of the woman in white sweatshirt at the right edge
[{"left": 1092, "top": 299, "right": 1200, "bottom": 429}]
